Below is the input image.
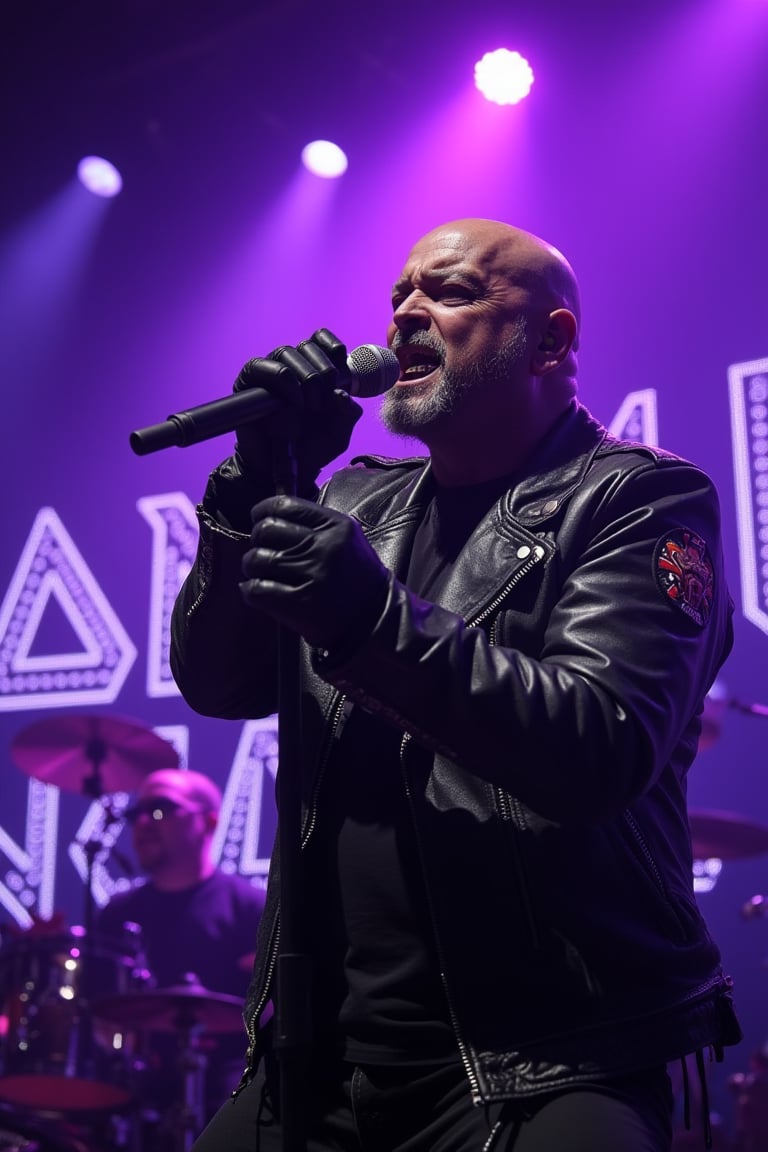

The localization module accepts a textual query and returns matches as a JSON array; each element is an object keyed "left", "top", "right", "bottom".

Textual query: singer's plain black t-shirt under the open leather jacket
[{"left": 305, "top": 477, "right": 511, "bottom": 1063}]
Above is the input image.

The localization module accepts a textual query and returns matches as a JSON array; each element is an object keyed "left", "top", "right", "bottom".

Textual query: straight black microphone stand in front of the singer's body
[{"left": 273, "top": 418, "right": 312, "bottom": 1152}]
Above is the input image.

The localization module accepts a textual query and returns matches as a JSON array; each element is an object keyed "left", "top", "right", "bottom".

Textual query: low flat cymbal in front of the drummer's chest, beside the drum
[{"left": 93, "top": 984, "right": 244, "bottom": 1032}]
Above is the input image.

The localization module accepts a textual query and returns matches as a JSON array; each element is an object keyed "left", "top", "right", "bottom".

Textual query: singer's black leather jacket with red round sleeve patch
[{"left": 172, "top": 406, "right": 740, "bottom": 1102}]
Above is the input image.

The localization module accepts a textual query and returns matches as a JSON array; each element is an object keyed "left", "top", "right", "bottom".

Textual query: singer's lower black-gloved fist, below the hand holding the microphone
[{"left": 239, "top": 495, "right": 389, "bottom": 650}]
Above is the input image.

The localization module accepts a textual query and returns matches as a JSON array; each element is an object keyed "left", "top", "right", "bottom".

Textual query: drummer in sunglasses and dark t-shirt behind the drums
[{"left": 96, "top": 768, "right": 264, "bottom": 1138}]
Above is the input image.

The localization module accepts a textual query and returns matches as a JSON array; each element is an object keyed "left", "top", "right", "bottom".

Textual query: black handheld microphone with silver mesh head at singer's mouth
[{"left": 129, "top": 344, "right": 400, "bottom": 456}]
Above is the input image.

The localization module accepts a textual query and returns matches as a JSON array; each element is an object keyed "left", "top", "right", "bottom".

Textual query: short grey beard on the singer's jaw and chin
[{"left": 380, "top": 317, "right": 526, "bottom": 440}]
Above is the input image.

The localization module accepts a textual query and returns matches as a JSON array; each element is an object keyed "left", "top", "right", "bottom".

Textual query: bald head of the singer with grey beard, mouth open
[{"left": 381, "top": 219, "right": 580, "bottom": 484}]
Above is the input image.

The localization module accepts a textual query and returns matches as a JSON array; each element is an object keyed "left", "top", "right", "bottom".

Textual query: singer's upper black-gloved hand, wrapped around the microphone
[{"left": 233, "top": 328, "right": 363, "bottom": 495}]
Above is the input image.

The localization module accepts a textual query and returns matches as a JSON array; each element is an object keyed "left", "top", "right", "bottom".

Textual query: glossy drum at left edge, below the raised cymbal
[{"left": 0, "top": 929, "right": 149, "bottom": 1113}]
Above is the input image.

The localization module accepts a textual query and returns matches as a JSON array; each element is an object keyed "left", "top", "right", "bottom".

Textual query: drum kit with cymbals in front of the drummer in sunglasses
[{"left": 0, "top": 715, "right": 243, "bottom": 1152}]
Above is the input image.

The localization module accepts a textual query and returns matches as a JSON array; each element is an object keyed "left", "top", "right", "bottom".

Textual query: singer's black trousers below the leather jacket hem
[{"left": 192, "top": 1063, "right": 672, "bottom": 1152}]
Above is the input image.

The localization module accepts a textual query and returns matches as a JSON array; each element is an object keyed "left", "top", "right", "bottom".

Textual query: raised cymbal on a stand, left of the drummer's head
[{"left": 10, "top": 715, "right": 178, "bottom": 796}]
